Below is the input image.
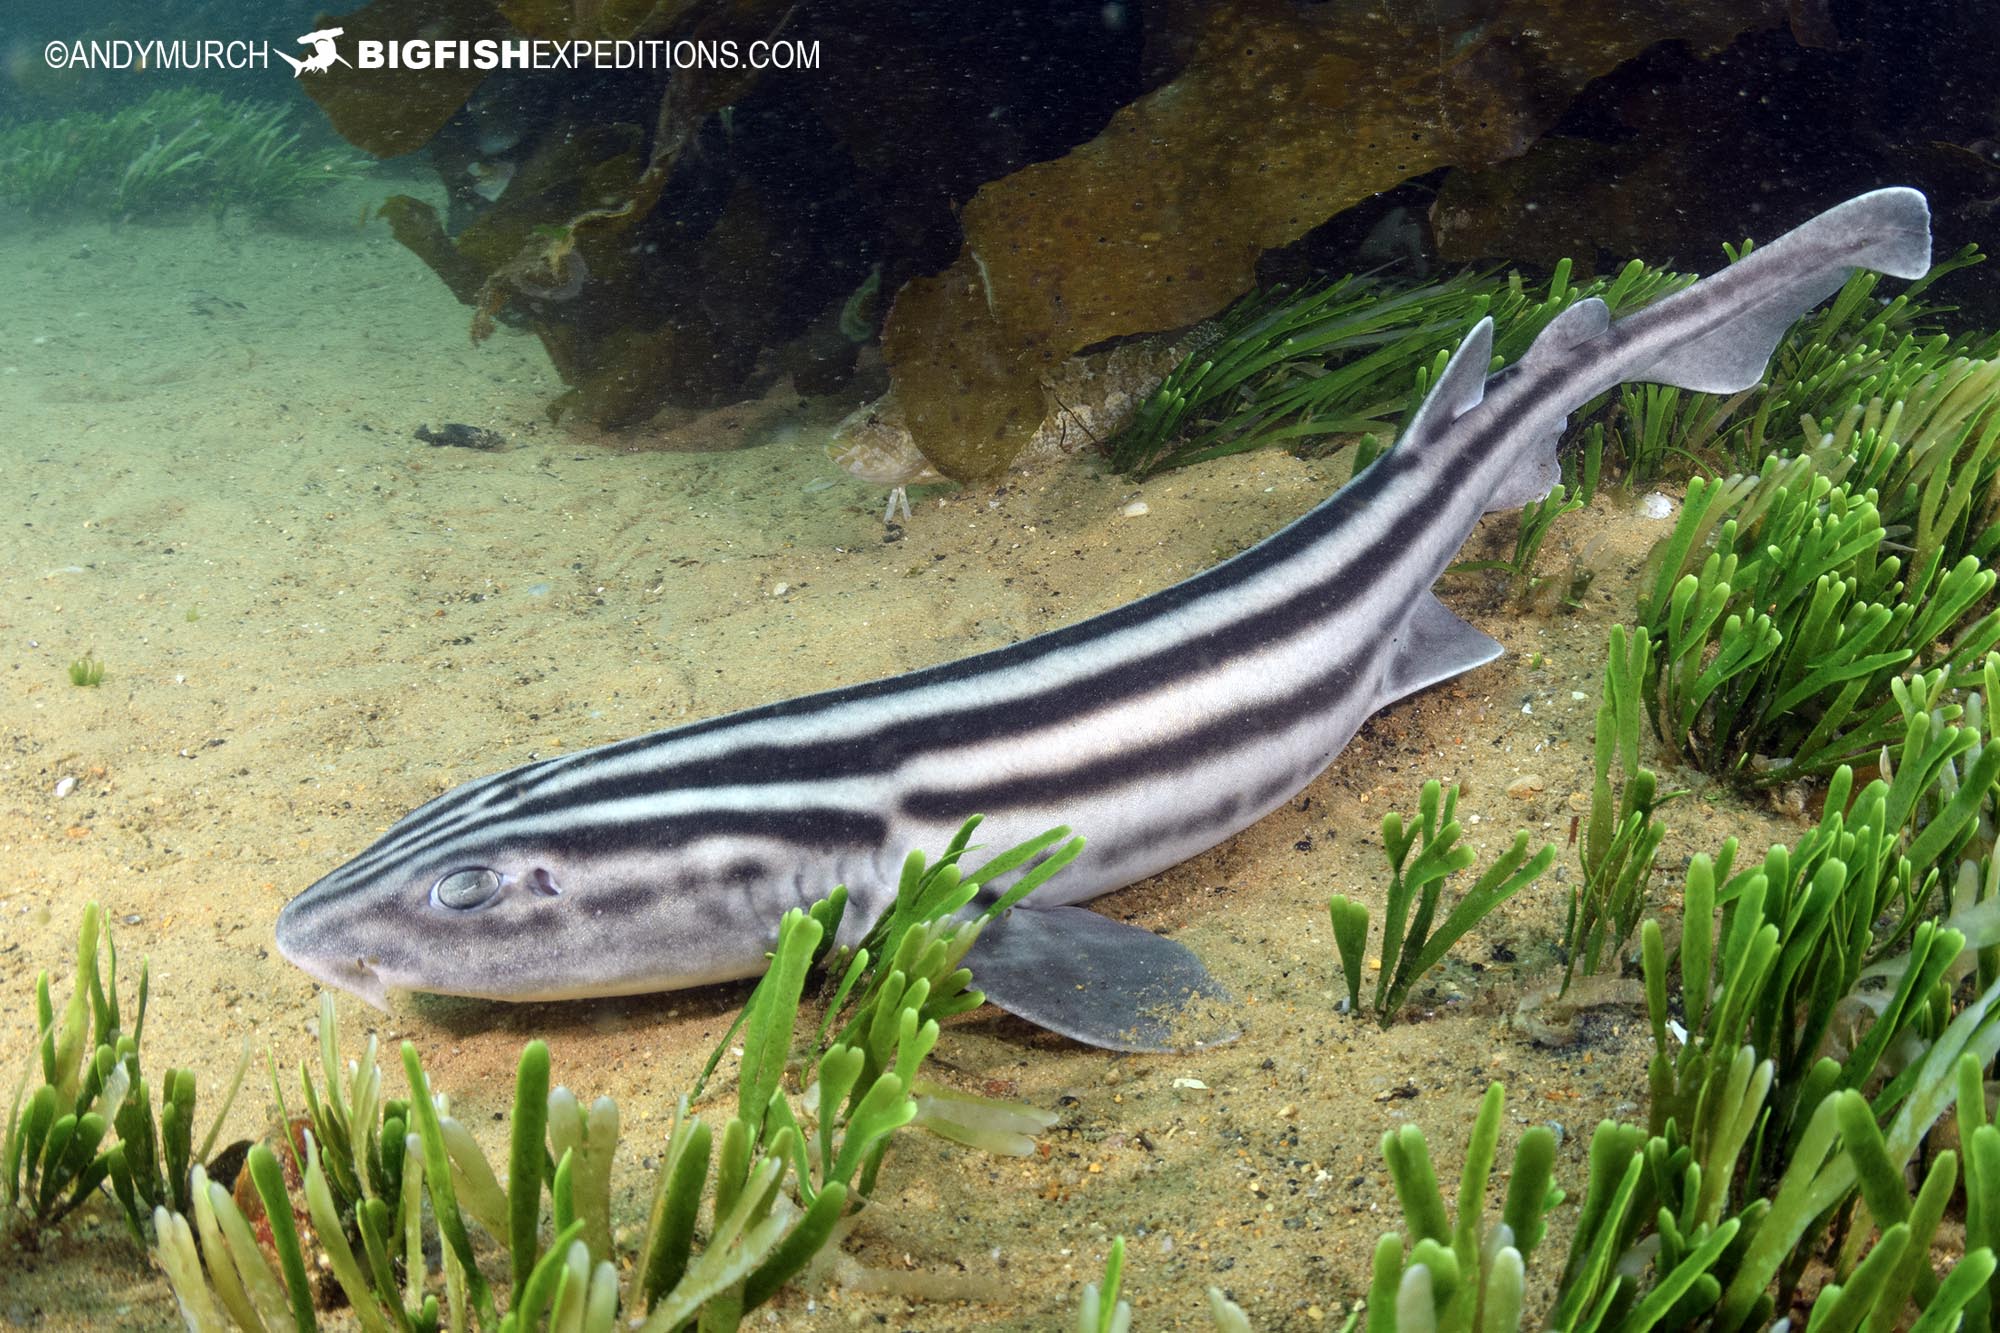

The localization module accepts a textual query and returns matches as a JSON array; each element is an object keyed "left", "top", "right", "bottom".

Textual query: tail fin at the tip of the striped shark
[{"left": 1618, "top": 186, "right": 1930, "bottom": 394}]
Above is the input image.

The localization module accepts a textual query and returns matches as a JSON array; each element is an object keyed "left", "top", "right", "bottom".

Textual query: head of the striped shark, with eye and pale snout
[{"left": 276, "top": 752, "right": 824, "bottom": 1007}]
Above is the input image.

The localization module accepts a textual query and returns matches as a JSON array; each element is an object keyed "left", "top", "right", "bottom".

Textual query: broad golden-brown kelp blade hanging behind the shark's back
[{"left": 884, "top": 0, "right": 1782, "bottom": 480}]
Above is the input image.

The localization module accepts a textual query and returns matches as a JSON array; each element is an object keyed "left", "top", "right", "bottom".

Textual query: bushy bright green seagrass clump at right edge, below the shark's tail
[{"left": 1640, "top": 360, "right": 2000, "bottom": 787}]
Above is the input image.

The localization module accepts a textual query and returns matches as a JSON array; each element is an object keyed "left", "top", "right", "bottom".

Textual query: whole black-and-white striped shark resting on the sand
[{"left": 278, "top": 188, "right": 1930, "bottom": 1051}]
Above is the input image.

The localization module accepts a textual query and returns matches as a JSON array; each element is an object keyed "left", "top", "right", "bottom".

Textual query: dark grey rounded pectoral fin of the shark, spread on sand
[{"left": 966, "top": 907, "right": 1240, "bottom": 1051}]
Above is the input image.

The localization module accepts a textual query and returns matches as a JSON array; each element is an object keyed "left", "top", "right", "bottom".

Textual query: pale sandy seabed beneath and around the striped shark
[{"left": 0, "top": 180, "right": 1798, "bottom": 1329}]
